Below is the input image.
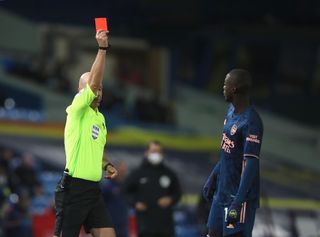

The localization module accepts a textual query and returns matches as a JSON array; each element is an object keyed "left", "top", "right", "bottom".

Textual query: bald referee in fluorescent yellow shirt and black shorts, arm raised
[{"left": 54, "top": 30, "right": 117, "bottom": 237}]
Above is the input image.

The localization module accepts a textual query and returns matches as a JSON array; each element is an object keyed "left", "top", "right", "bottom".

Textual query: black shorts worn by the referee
[{"left": 54, "top": 177, "right": 113, "bottom": 237}]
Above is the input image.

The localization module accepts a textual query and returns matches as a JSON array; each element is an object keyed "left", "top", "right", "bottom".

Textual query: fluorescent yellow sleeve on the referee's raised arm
[{"left": 67, "top": 84, "right": 96, "bottom": 114}]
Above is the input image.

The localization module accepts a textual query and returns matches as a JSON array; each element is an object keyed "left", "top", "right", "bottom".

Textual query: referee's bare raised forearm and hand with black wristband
[{"left": 88, "top": 30, "right": 109, "bottom": 94}]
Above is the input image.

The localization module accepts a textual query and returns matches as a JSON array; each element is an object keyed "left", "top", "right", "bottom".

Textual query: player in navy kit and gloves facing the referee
[{"left": 203, "top": 69, "right": 263, "bottom": 237}]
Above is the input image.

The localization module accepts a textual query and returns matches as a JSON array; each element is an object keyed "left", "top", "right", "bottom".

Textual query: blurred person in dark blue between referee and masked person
[{"left": 100, "top": 161, "right": 129, "bottom": 237}]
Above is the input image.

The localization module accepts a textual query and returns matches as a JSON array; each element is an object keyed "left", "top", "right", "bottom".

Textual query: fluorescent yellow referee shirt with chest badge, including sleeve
[{"left": 64, "top": 84, "right": 107, "bottom": 181}]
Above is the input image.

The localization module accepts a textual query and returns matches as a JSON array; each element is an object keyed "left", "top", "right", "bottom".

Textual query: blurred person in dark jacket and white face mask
[{"left": 123, "top": 141, "right": 181, "bottom": 237}]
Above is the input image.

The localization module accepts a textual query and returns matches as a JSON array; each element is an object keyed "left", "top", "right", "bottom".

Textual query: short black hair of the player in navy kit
[{"left": 229, "top": 69, "right": 252, "bottom": 94}]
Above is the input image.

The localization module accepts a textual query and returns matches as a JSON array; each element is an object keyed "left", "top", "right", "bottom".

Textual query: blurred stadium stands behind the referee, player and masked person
[{"left": 0, "top": 0, "right": 320, "bottom": 237}]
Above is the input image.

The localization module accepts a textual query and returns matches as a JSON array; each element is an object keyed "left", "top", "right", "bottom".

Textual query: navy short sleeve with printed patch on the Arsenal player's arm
[{"left": 243, "top": 113, "right": 263, "bottom": 159}]
